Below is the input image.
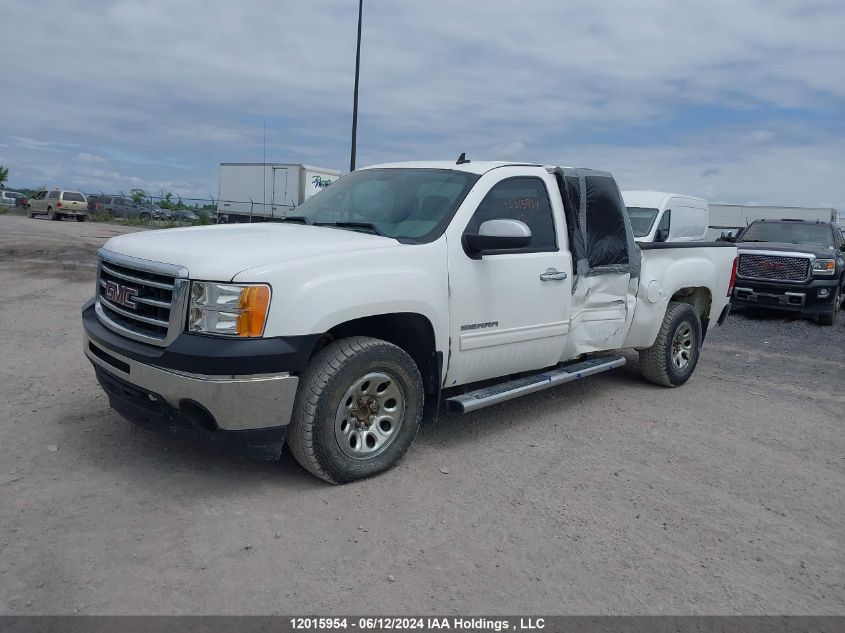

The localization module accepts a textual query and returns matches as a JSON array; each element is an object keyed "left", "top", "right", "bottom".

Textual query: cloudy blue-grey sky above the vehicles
[{"left": 0, "top": 0, "right": 845, "bottom": 211}]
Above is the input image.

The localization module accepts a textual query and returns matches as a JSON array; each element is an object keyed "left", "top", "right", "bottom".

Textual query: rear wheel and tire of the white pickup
[{"left": 640, "top": 301, "right": 702, "bottom": 387}]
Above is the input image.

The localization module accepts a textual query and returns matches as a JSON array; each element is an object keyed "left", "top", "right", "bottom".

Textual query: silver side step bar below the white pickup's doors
[{"left": 446, "top": 356, "right": 625, "bottom": 413}]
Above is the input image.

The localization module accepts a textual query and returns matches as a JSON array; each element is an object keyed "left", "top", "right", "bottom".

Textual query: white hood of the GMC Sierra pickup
[{"left": 105, "top": 222, "right": 399, "bottom": 281}]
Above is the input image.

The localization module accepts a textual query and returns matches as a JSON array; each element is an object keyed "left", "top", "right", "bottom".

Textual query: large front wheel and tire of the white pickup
[{"left": 287, "top": 336, "right": 425, "bottom": 484}]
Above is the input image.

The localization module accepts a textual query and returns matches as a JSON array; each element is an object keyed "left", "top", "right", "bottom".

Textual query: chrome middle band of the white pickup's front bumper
[{"left": 83, "top": 335, "right": 299, "bottom": 431}]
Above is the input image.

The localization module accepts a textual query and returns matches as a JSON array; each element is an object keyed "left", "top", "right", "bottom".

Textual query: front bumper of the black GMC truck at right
[{"left": 731, "top": 277, "right": 839, "bottom": 314}]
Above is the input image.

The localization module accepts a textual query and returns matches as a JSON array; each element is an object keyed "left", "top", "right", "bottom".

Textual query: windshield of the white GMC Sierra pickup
[{"left": 292, "top": 168, "right": 478, "bottom": 242}]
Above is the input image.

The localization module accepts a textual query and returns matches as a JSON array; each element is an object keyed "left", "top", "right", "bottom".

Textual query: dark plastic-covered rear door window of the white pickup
[{"left": 586, "top": 175, "right": 628, "bottom": 268}]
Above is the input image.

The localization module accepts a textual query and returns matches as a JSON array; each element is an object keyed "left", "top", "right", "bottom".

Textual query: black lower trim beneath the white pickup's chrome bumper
[{"left": 94, "top": 365, "right": 287, "bottom": 460}]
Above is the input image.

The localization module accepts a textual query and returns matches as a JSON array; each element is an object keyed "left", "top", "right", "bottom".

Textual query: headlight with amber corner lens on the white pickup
[{"left": 188, "top": 281, "right": 270, "bottom": 336}]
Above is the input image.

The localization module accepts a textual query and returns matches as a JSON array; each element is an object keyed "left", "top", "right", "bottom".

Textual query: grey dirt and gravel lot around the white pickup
[{"left": 0, "top": 216, "right": 845, "bottom": 614}]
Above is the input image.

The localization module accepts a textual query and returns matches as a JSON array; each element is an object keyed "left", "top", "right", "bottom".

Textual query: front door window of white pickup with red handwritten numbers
[{"left": 467, "top": 178, "right": 557, "bottom": 251}]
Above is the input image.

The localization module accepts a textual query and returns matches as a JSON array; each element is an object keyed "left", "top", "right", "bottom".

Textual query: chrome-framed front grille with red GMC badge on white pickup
[{"left": 97, "top": 253, "right": 184, "bottom": 345}]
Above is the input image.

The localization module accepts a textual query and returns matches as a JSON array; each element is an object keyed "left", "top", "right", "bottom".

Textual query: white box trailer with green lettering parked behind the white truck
[{"left": 217, "top": 163, "right": 341, "bottom": 222}]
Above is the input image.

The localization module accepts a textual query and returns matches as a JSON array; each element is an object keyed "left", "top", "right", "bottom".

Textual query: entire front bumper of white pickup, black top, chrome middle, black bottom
[{"left": 82, "top": 302, "right": 311, "bottom": 459}]
